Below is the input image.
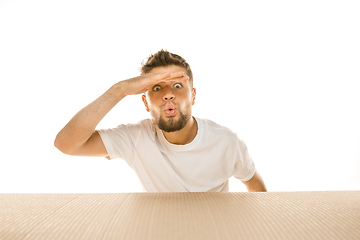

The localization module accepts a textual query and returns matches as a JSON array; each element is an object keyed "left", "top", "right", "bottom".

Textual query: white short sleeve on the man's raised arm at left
[{"left": 96, "top": 125, "right": 135, "bottom": 162}]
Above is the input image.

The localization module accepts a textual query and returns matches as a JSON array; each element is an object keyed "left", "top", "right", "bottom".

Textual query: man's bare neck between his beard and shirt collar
[{"left": 163, "top": 117, "right": 198, "bottom": 145}]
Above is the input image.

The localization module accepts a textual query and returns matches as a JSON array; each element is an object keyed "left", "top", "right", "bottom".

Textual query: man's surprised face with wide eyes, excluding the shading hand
[{"left": 143, "top": 65, "right": 196, "bottom": 132}]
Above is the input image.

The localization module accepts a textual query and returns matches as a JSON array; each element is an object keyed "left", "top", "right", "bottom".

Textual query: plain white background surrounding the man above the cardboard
[{"left": 0, "top": 0, "right": 360, "bottom": 193}]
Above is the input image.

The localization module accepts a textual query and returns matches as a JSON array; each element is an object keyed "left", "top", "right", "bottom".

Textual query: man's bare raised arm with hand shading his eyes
[{"left": 54, "top": 72, "right": 188, "bottom": 157}]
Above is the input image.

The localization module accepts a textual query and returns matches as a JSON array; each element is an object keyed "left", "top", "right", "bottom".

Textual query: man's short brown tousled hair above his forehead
[{"left": 140, "top": 49, "right": 193, "bottom": 85}]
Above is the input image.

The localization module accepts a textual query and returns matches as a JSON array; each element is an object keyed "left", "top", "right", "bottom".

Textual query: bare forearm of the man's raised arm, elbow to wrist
[{"left": 55, "top": 82, "right": 125, "bottom": 153}]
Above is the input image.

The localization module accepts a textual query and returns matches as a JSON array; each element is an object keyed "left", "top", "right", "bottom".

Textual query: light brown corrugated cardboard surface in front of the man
[{"left": 0, "top": 191, "right": 360, "bottom": 240}]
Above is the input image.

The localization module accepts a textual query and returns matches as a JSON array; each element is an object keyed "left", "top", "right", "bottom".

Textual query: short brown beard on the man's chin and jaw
[{"left": 153, "top": 108, "right": 191, "bottom": 132}]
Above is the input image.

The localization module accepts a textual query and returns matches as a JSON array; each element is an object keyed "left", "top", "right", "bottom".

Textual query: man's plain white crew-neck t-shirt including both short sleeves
[{"left": 97, "top": 118, "right": 255, "bottom": 192}]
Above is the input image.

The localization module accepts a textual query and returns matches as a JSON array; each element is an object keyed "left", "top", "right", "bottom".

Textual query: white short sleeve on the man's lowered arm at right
[{"left": 233, "top": 139, "right": 256, "bottom": 182}]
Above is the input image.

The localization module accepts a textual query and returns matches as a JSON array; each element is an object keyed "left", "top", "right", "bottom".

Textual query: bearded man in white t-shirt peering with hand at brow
[{"left": 55, "top": 50, "right": 266, "bottom": 192}]
